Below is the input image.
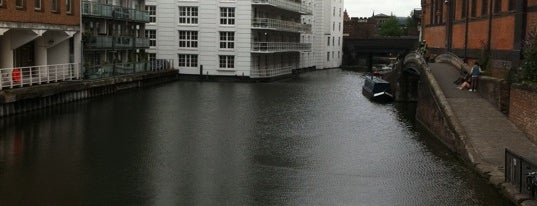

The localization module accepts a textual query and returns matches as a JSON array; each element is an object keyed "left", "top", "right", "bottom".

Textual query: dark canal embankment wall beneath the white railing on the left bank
[{"left": 0, "top": 70, "right": 178, "bottom": 117}]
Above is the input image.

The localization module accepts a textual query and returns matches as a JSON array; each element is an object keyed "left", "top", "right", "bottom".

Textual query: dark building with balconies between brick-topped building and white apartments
[{"left": 81, "top": 0, "right": 152, "bottom": 79}]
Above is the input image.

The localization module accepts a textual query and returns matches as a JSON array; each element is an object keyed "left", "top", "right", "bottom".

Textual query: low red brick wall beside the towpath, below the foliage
[{"left": 509, "top": 86, "right": 537, "bottom": 143}]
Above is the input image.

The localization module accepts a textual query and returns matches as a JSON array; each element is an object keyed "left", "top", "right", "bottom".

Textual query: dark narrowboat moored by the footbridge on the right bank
[{"left": 362, "top": 76, "right": 393, "bottom": 102}]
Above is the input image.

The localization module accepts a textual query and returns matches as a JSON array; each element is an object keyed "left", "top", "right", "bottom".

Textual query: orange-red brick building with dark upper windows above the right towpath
[{"left": 421, "top": 0, "right": 537, "bottom": 78}]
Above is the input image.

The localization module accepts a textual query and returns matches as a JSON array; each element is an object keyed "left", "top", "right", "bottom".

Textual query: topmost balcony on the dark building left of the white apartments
[{"left": 82, "top": 1, "right": 149, "bottom": 23}]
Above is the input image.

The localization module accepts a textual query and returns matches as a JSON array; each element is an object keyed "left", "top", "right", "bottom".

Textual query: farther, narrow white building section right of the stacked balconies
[{"left": 300, "top": 0, "right": 344, "bottom": 69}]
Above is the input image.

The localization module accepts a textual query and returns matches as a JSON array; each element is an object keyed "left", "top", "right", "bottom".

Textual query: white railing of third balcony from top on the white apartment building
[{"left": 252, "top": 42, "right": 311, "bottom": 53}]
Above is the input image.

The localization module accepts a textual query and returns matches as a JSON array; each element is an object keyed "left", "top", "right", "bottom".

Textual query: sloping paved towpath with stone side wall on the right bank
[{"left": 410, "top": 55, "right": 537, "bottom": 205}]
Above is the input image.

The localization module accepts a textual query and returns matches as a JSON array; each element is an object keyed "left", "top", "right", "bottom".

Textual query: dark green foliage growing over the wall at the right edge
[{"left": 517, "top": 30, "right": 537, "bottom": 83}]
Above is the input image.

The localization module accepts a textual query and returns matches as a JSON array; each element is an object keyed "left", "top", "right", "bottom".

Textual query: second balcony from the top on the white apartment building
[{"left": 252, "top": 18, "right": 311, "bottom": 33}]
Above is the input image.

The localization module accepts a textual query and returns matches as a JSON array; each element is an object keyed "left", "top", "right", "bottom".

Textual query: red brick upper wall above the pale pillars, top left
[{"left": 0, "top": 0, "right": 80, "bottom": 26}]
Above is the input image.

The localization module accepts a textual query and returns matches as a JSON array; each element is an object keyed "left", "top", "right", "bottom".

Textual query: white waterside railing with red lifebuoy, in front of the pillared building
[{"left": 0, "top": 63, "right": 80, "bottom": 90}]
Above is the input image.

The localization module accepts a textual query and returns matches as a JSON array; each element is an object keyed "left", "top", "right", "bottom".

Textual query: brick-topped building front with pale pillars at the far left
[{"left": 0, "top": 0, "right": 81, "bottom": 89}]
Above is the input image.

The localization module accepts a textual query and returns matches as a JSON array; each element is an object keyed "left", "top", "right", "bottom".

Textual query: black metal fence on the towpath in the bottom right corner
[{"left": 505, "top": 149, "right": 537, "bottom": 199}]
